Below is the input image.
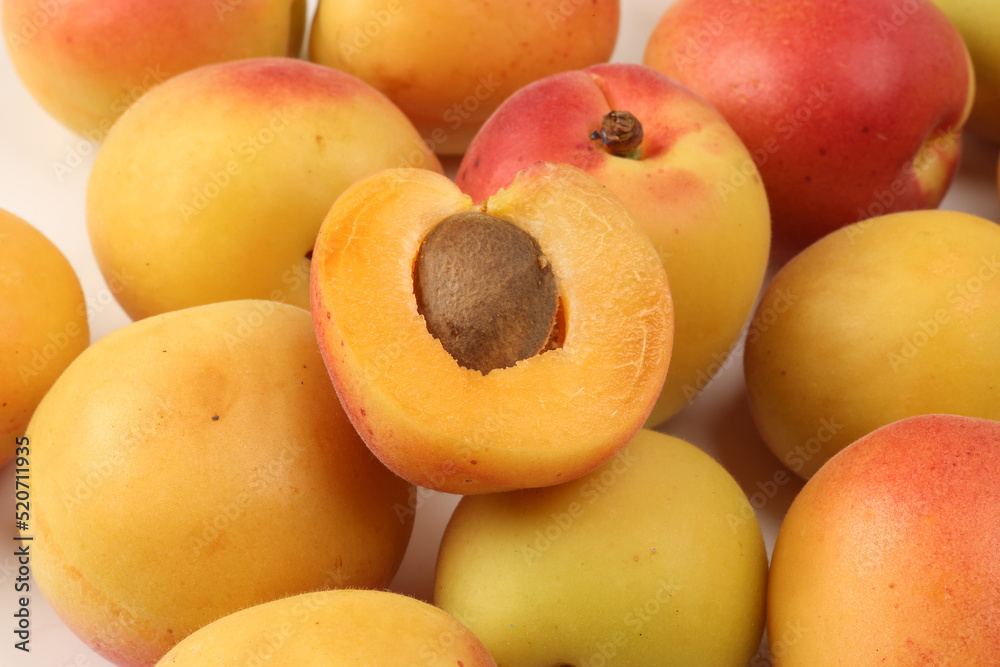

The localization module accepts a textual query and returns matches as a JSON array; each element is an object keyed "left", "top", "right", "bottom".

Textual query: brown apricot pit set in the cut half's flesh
[{"left": 413, "top": 211, "right": 559, "bottom": 375}]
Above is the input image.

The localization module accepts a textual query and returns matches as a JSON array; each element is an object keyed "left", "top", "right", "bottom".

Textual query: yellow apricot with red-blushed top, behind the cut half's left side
[{"left": 87, "top": 58, "right": 441, "bottom": 319}]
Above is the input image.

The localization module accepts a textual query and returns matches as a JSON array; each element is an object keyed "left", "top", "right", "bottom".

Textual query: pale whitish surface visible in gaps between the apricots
[{"left": 0, "top": 0, "right": 1000, "bottom": 667}]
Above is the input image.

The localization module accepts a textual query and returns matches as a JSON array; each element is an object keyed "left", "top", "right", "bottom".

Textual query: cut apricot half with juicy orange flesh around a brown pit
[{"left": 311, "top": 163, "right": 673, "bottom": 494}]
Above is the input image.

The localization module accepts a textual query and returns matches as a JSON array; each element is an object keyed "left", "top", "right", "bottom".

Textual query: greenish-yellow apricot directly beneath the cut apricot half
[{"left": 434, "top": 430, "right": 768, "bottom": 667}]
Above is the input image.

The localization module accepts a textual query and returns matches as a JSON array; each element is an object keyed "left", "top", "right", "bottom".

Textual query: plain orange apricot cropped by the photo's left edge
[{"left": 0, "top": 209, "right": 90, "bottom": 466}]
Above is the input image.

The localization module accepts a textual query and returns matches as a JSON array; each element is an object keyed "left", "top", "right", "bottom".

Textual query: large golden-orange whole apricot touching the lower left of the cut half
[{"left": 28, "top": 301, "right": 412, "bottom": 665}]
